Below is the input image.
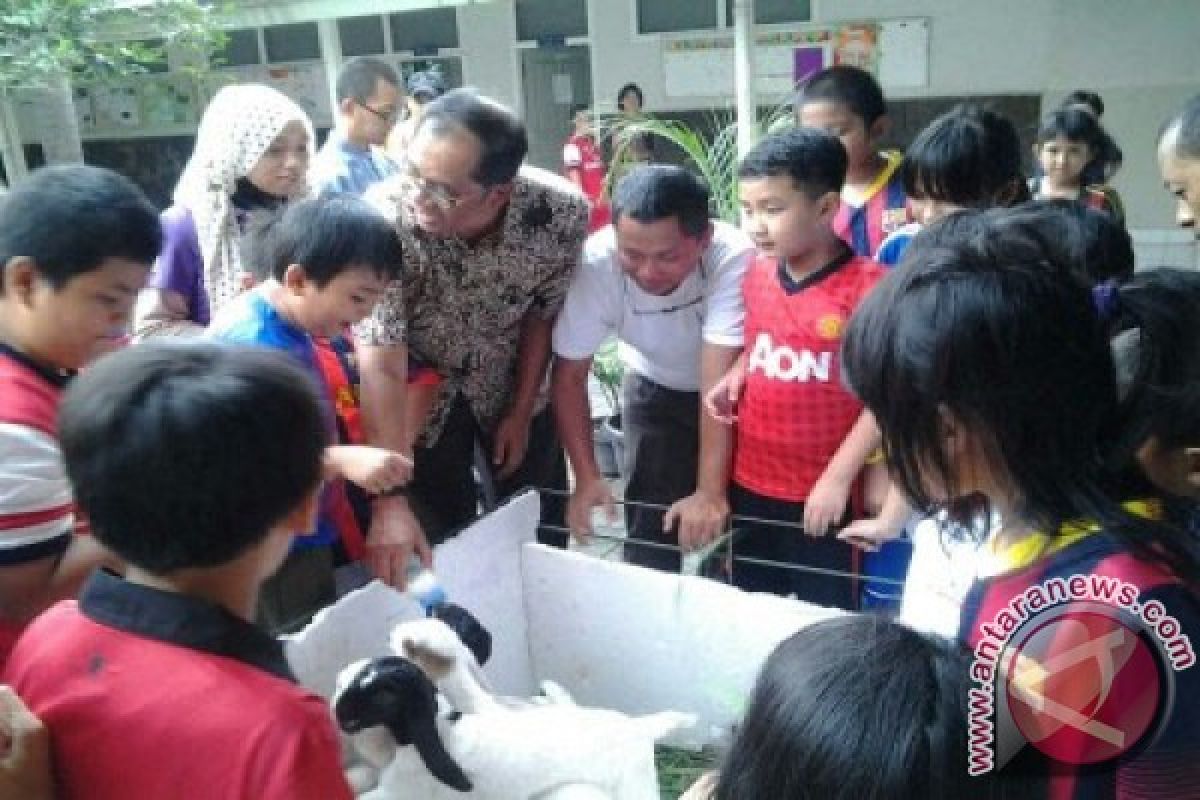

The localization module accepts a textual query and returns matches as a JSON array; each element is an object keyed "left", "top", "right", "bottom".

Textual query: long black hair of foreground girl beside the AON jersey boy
[{"left": 841, "top": 209, "right": 1200, "bottom": 585}]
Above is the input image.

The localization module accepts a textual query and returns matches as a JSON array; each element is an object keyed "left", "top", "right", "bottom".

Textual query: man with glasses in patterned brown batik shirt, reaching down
[{"left": 358, "top": 89, "right": 588, "bottom": 585}]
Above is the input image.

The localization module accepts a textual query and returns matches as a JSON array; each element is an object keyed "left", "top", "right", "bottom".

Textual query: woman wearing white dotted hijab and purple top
[{"left": 133, "top": 84, "right": 313, "bottom": 337}]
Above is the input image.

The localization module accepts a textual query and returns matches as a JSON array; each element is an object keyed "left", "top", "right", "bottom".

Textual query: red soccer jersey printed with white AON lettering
[{"left": 733, "top": 252, "right": 883, "bottom": 503}]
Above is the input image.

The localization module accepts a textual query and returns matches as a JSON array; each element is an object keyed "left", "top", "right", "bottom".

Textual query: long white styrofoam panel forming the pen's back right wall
[{"left": 524, "top": 545, "right": 841, "bottom": 746}]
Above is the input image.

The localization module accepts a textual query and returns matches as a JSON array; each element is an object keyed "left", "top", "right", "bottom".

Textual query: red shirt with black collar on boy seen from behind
[{"left": 4, "top": 573, "right": 352, "bottom": 800}]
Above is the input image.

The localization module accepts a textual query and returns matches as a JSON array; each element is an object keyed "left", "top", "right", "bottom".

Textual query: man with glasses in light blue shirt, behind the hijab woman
[{"left": 312, "top": 56, "right": 404, "bottom": 194}]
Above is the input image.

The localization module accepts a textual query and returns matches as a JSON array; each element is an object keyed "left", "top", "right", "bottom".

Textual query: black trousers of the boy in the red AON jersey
[{"left": 730, "top": 483, "right": 858, "bottom": 609}]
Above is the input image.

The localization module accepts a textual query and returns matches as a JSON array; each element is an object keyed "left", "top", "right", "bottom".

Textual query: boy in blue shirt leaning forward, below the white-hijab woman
[{"left": 209, "top": 194, "right": 410, "bottom": 630}]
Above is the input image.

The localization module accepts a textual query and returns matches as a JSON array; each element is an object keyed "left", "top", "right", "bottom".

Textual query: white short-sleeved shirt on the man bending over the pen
[{"left": 554, "top": 221, "right": 754, "bottom": 391}]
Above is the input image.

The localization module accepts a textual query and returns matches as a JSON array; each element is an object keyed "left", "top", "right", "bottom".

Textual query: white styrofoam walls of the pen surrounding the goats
[{"left": 286, "top": 493, "right": 842, "bottom": 746}]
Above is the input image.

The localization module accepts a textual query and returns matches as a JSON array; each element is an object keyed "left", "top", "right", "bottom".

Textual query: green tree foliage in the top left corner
[{"left": 0, "top": 0, "right": 223, "bottom": 89}]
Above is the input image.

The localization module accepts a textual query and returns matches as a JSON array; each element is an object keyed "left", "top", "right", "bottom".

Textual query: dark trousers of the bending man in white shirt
[{"left": 622, "top": 373, "right": 700, "bottom": 572}]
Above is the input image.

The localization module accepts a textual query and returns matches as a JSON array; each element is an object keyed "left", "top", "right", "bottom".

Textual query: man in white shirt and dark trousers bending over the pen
[{"left": 552, "top": 164, "right": 754, "bottom": 571}]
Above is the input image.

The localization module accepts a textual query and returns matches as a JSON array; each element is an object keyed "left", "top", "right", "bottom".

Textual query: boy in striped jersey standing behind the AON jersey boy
[{"left": 796, "top": 66, "right": 913, "bottom": 257}]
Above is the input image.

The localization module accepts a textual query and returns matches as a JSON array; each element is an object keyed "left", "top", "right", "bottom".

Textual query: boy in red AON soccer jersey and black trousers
[{"left": 708, "top": 128, "right": 882, "bottom": 608}]
